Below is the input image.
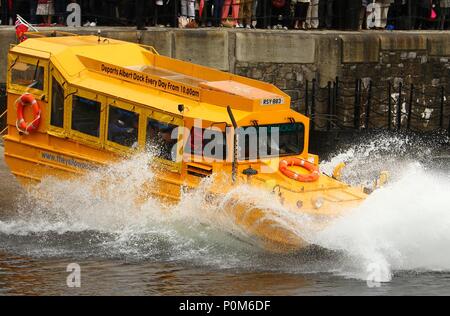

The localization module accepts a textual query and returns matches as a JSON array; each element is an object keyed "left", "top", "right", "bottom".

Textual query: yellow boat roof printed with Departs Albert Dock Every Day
[{"left": 11, "top": 35, "right": 296, "bottom": 122}]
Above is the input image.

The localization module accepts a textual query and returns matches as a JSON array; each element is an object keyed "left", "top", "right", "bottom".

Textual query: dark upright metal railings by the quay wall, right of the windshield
[{"left": 297, "top": 77, "right": 450, "bottom": 136}]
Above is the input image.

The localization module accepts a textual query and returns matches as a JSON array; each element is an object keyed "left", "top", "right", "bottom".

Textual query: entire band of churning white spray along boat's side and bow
[{"left": 0, "top": 136, "right": 450, "bottom": 281}]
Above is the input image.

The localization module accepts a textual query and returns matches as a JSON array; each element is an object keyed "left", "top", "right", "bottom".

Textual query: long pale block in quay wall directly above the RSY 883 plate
[{"left": 236, "top": 32, "right": 316, "bottom": 64}]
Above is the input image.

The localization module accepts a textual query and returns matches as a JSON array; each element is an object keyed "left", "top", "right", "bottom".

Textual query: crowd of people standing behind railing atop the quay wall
[{"left": 1, "top": 0, "right": 450, "bottom": 30}]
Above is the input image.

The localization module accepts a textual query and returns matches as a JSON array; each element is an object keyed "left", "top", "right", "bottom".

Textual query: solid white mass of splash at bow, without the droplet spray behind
[{"left": 315, "top": 164, "right": 450, "bottom": 282}]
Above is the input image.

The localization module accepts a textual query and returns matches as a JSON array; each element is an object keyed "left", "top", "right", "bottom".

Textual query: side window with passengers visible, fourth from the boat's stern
[{"left": 146, "top": 118, "right": 178, "bottom": 161}]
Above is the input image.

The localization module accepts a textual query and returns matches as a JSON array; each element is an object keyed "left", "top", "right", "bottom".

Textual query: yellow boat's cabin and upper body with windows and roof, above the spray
[{"left": 5, "top": 36, "right": 317, "bottom": 189}]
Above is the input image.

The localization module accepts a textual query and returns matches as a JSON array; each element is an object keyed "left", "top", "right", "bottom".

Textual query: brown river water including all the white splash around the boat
[{"left": 0, "top": 135, "right": 450, "bottom": 295}]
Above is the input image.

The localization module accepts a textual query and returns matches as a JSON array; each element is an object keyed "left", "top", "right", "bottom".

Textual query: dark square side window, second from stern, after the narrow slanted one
[{"left": 72, "top": 95, "right": 101, "bottom": 137}]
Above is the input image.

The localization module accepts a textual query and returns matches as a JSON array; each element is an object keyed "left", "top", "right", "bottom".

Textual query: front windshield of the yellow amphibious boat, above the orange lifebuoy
[{"left": 237, "top": 123, "right": 305, "bottom": 160}]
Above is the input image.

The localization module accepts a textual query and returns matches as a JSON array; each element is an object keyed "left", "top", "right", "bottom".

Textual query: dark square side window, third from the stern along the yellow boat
[{"left": 108, "top": 105, "right": 139, "bottom": 147}]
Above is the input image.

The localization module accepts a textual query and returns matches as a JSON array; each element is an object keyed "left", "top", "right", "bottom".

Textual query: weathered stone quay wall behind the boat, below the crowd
[{"left": 0, "top": 27, "right": 450, "bottom": 131}]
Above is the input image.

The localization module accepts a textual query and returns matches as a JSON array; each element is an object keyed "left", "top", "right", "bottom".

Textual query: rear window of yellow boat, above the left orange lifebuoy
[{"left": 11, "top": 61, "right": 44, "bottom": 90}]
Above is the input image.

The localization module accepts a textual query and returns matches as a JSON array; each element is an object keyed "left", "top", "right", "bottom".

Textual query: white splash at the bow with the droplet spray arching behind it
[{"left": 312, "top": 134, "right": 450, "bottom": 282}]
